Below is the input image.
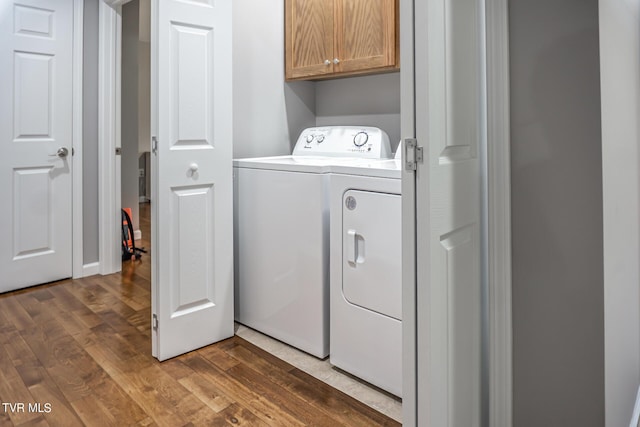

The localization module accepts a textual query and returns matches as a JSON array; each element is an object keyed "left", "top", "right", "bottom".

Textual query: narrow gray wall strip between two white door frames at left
[{"left": 82, "top": 0, "right": 102, "bottom": 264}]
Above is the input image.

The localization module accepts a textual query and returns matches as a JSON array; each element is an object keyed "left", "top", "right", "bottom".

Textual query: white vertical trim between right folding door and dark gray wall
[{"left": 486, "top": 0, "right": 513, "bottom": 427}]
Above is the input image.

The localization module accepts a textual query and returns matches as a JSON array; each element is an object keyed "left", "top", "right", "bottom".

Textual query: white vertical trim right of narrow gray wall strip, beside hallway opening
[{"left": 98, "top": 2, "right": 122, "bottom": 274}]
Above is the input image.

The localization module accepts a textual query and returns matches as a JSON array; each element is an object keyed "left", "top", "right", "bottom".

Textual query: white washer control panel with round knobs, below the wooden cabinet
[{"left": 293, "top": 126, "right": 391, "bottom": 159}]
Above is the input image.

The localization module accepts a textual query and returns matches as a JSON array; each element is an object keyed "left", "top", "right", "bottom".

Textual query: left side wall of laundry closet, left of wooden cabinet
[{"left": 233, "top": 0, "right": 315, "bottom": 158}]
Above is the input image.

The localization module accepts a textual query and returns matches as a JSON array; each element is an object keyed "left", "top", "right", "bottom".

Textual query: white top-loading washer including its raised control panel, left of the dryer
[{"left": 234, "top": 126, "right": 391, "bottom": 358}]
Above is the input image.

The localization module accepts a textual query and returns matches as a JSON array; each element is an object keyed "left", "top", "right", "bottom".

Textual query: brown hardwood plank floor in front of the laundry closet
[{"left": 0, "top": 207, "right": 400, "bottom": 426}]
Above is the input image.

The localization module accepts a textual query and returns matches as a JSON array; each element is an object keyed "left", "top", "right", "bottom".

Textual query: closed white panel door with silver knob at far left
[{"left": 0, "top": 0, "right": 73, "bottom": 292}]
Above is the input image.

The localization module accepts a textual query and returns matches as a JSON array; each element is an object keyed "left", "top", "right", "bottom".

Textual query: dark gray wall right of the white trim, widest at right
[{"left": 509, "top": 0, "right": 604, "bottom": 427}]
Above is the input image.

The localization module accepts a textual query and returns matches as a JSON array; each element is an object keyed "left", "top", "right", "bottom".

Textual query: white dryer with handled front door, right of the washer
[{"left": 329, "top": 152, "right": 402, "bottom": 396}]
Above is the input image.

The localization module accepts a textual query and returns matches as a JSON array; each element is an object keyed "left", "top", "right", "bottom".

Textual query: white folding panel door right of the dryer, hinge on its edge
[{"left": 415, "top": 0, "right": 485, "bottom": 427}]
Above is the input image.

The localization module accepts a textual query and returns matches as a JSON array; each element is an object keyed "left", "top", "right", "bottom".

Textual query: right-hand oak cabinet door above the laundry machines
[{"left": 332, "top": 0, "right": 397, "bottom": 73}]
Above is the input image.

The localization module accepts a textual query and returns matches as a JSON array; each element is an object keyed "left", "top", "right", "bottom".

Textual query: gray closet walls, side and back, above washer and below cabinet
[{"left": 233, "top": 0, "right": 400, "bottom": 158}]
